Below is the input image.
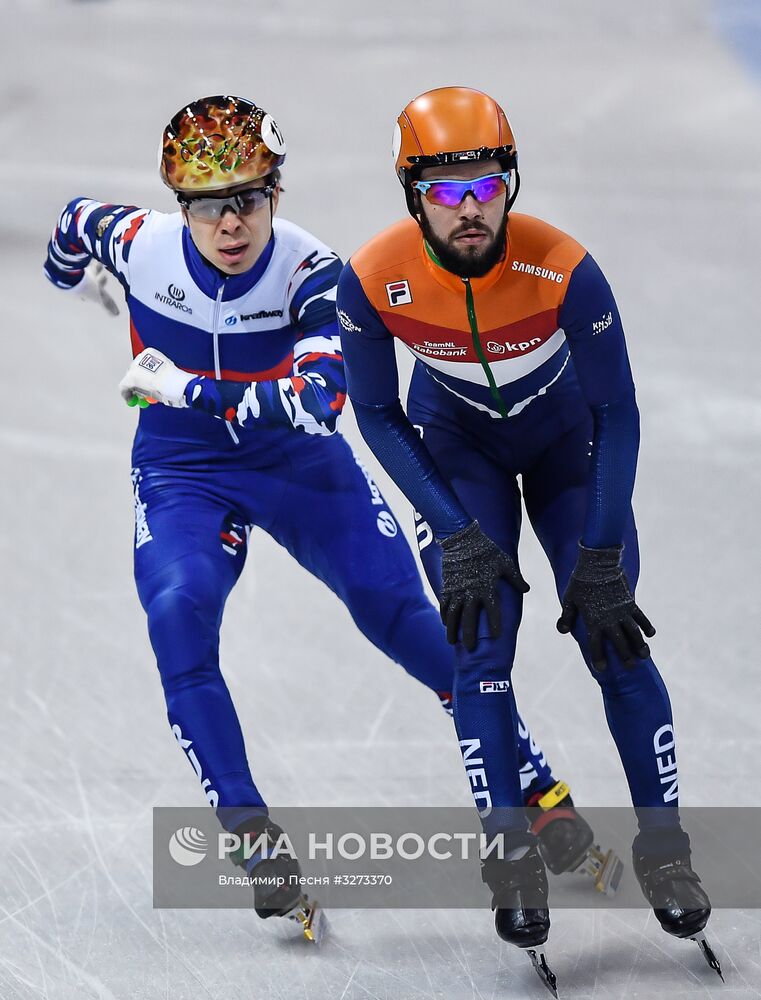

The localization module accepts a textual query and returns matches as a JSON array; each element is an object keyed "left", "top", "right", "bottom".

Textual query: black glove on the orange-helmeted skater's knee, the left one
[{"left": 441, "top": 521, "right": 529, "bottom": 650}]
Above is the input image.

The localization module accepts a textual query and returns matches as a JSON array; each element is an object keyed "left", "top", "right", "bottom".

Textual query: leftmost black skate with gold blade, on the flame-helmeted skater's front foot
[{"left": 232, "top": 816, "right": 327, "bottom": 944}]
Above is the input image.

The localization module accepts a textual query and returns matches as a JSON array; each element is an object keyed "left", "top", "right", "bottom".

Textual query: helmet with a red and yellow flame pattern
[{"left": 159, "top": 96, "right": 285, "bottom": 194}]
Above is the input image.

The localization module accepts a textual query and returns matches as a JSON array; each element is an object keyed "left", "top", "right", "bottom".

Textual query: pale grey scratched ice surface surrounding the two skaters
[{"left": 0, "top": 0, "right": 761, "bottom": 1000}]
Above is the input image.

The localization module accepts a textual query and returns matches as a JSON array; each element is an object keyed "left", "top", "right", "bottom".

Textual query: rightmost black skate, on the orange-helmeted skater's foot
[{"left": 632, "top": 830, "right": 724, "bottom": 982}]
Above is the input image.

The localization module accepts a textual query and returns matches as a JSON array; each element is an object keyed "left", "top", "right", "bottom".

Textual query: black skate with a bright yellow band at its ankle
[{"left": 527, "top": 781, "right": 624, "bottom": 896}]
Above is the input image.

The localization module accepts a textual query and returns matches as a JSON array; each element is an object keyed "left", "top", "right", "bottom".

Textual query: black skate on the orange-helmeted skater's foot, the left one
[{"left": 481, "top": 844, "right": 558, "bottom": 997}]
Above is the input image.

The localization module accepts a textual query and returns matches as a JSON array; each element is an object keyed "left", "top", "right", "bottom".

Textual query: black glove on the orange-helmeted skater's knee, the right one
[{"left": 558, "top": 542, "right": 655, "bottom": 670}]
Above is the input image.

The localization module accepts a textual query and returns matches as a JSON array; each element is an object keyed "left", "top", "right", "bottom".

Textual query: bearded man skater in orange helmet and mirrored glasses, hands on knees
[{"left": 338, "top": 87, "right": 718, "bottom": 988}]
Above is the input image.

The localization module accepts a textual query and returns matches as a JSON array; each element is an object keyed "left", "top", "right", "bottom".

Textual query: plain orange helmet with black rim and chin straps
[{"left": 393, "top": 87, "right": 520, "bottom": 219}]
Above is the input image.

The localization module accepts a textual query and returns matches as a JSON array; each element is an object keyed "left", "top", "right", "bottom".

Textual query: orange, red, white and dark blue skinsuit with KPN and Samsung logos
[{"left": 338, "top": 214, "right": 678, "bottom": 848}]
